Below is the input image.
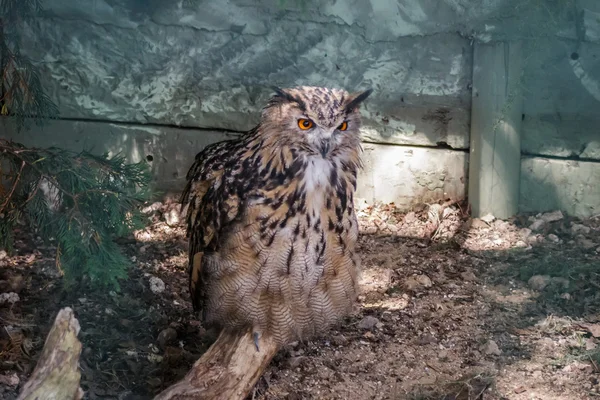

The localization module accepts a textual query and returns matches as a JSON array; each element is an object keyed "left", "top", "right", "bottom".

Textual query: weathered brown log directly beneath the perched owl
[{"left": 154, "top": 331, "right": 279, "bottom": 400}]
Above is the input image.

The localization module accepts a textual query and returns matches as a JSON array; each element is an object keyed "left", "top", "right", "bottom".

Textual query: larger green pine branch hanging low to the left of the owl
[{"left": 0, "top": 139, "right": 151, "bottom": 288}]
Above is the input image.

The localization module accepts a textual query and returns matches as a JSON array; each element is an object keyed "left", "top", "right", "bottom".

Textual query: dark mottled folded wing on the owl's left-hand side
[{"left": 181, "top": 141, "right": 240, "bottom": 310}]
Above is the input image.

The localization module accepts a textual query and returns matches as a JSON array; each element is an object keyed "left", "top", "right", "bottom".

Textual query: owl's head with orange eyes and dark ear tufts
[{"left": 261, "top": 86, "right": 372, "bottom": 159}]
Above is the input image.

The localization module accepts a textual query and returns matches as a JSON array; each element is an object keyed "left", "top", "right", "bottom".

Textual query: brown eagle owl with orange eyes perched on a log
[{"left": 181, "top": 87, "right": 371, "bottom": 344}]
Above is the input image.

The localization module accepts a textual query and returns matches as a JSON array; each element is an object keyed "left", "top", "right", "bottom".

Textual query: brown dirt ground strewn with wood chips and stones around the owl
[{"left": 0, "top": 203, "right": 600, "bottom": 400}]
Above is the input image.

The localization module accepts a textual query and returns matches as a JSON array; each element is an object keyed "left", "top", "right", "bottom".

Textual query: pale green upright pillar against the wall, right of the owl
[{"left": 469, "top": 42, "right": 523, "bottom": 219}]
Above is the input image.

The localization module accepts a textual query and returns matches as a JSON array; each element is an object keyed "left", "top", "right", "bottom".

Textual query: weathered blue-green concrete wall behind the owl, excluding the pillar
[{"left": 0, "top": 0, "right": 600, "bottom": 217}]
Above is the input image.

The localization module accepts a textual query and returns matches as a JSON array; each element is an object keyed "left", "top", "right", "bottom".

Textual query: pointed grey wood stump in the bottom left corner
[{"left": 17, "top": 307, "right": 83, "bottom": 400}]
